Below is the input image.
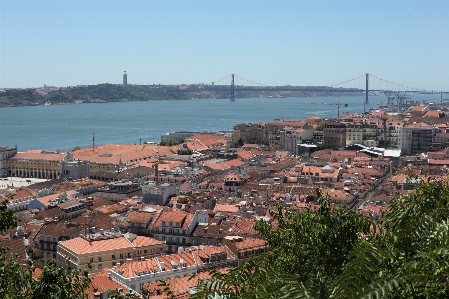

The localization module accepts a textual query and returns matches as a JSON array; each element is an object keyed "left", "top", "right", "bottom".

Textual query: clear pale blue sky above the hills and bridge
[{"left": 0, "top": 0, "right": 449, "bottom": 91}]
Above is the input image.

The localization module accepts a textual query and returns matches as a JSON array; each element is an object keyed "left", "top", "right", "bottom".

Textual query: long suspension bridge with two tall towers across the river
[{"left": 178, "top": 73, "right": 449, "bottom": 106}]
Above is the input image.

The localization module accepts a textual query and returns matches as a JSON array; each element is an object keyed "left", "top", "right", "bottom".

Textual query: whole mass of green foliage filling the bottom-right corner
[{"left": 193, "top": 178, "right": 449, "bottom": 298}]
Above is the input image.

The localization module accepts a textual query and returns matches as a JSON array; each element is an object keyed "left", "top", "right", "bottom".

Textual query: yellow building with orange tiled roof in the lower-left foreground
[{"left": 57, "top": 232, "right": 166, "bottom": 271}]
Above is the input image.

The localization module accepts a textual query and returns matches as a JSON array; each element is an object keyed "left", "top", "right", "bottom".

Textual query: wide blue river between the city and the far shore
[{"left": 0, "top": 95, "right": 439, "bottom": 151}]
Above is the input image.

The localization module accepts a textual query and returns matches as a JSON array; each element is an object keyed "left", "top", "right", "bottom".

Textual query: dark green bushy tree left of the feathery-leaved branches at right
[{"left": 194, "top": 190, "right": 371, "bottom": 298}]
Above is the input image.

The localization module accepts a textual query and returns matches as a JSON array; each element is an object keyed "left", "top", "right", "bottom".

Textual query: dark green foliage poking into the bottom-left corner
[{"left": 0, "top": 200, "right": 90, "bottom": 299}]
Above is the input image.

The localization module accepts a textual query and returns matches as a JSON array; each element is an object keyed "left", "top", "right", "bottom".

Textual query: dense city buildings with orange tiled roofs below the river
[{"left": 0, "top": 106, "right": 449, "bottom": 298}]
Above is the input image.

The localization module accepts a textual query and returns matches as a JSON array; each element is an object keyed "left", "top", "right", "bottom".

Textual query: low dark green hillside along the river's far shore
[{"left": 0, "top": 83, "right": 360, "bottom": 107}]
